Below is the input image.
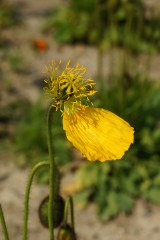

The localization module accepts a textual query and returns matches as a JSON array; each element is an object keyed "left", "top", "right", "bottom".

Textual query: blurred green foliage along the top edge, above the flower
[{"left": 44, "top": 0, "right": 160, "bottom": 53}]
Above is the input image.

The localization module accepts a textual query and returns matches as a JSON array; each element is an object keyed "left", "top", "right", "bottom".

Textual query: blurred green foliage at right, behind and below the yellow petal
[{"left": 75, "top": 74, "right": 160, "bottom": 220}]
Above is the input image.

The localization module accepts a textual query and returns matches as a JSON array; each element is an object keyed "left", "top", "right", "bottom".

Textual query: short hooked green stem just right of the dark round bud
[{"left": 64, "top": 196, "right": 75, "bottom": 232}]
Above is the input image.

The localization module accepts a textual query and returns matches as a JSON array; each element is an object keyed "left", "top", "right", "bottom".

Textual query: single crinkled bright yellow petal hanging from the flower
[{"left": 63, "top": 107, "right": 134, "bottom": 162}]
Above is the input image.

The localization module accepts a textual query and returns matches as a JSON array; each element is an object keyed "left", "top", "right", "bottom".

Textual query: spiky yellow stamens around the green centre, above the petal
[{"left": 45, "top": 61, "right": 95, "bottom": 110}]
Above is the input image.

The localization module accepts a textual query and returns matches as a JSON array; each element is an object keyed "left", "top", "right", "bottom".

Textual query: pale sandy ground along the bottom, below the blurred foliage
[{"left": 0, "top": 154, "right": 160, "bottom": 240}]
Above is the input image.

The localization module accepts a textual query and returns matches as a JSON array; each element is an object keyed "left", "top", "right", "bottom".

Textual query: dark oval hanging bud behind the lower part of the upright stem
[{"left": 38, "top": 195, "right": 64, "bottom": 228}]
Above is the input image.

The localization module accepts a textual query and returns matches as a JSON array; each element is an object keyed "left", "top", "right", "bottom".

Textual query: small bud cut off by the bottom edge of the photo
[{"left": 57, "top": 224, "right": 76, "bottom": 240}]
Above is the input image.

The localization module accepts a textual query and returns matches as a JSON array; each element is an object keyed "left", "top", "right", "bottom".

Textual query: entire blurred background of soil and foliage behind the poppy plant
[{"left": 0, "top": 0, "right": 160, "bottom": 240}]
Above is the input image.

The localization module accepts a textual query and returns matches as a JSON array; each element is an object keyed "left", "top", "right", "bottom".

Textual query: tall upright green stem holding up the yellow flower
[{"left": 47, "top": 105, "right": 56, "bottom": 240}]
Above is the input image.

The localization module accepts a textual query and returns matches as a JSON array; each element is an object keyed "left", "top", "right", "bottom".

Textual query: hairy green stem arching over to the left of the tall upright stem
[{"left": 23, "top": 161, "right": 49, "bottom": 240}]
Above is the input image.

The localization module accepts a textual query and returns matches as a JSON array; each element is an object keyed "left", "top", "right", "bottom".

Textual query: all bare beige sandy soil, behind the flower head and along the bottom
[{"left": 0, "top": 0, "right": 160, "bottom": 240}]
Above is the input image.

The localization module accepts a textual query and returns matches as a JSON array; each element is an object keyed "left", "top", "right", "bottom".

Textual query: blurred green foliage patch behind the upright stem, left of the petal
[{"left": 14, "top": 101, "right": 70, "bottom": 183}]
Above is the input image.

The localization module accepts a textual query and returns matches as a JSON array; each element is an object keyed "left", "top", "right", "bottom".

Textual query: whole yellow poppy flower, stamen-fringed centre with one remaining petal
[{"left": 43, "top": 60, "right": 134, "bottom": 162}]
